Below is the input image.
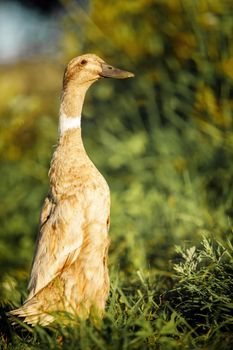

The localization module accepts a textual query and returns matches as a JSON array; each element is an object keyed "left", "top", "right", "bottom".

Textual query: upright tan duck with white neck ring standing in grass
[{"left": 10, "top": 54, "right": 134, "bottom": 326}]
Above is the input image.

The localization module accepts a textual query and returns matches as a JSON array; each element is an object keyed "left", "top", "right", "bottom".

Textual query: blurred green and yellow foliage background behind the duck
[{"left": 0, "top": 0, "right": 233, "bottom": 304}]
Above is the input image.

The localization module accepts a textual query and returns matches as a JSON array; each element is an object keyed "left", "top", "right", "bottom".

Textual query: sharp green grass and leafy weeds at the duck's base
[{"left": 1, "top": 238, "right": 233, "bottom": 349}]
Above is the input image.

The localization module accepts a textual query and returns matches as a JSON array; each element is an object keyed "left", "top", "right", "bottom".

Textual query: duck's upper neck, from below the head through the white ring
[{"left": 59, "top": 83, "right": 87, "bottom": 136}]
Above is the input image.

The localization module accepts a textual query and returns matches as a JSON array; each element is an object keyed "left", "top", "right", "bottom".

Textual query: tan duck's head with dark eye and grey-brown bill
[{"left": 64, "top": 54, "right": 134, "bottom": 87}]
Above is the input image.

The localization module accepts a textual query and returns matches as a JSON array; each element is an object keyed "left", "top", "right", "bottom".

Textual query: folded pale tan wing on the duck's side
[{"left": 27, "top": 193, "right": 85, "bottom": 300}]
